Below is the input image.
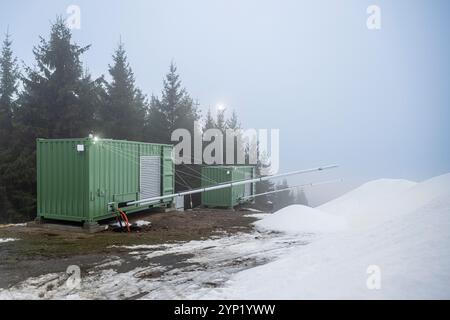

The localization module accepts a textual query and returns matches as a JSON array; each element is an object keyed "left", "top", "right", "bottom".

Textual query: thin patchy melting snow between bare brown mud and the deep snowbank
[{"left": 0, "top": 232, "right": 314, "bottom": 299}]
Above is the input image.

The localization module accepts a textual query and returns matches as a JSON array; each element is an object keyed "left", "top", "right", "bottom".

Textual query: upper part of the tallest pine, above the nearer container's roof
[{"left": 20, "top": 17, "right": 101, "bottom": 138}]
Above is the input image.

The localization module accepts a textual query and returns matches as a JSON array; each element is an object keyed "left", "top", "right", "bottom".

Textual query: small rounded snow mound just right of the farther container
[{"left": 255, "top": 205, "right": 346, "bottom": 234}]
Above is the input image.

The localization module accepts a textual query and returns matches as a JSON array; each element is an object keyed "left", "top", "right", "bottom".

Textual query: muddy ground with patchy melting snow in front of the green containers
[{"left": 0, "top": 210, "right": 313, "bottom": 299}]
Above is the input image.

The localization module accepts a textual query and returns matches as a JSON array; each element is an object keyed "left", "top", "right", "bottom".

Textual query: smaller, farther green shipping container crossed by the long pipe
[{"left": 202, "top": 166, "right": 255, "bottom": 208}]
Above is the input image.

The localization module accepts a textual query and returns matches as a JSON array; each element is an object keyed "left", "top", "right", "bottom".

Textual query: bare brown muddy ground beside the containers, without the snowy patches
[{"left": 0, "top": 209, "right": 255, "bottom": 288}]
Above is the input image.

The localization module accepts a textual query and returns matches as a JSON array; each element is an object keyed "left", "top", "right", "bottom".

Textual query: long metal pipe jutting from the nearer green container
[{"left": 125, "top": 165, "right": 338, "bottom": 207}]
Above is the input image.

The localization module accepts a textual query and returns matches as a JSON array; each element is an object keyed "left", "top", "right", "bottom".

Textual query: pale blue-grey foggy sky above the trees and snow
[{"left": 0, "top": 0, "right": 450, "bottom": 201}]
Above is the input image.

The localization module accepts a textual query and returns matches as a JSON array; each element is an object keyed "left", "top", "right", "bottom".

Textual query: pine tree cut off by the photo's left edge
[{"left": 0, "top": 32, "right": 20, "bottom": 222}]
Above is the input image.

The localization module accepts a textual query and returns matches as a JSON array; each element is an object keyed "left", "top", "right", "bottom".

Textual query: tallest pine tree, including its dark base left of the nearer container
[{"left": 3, "top": 17, "right": 102, "bottom": 218}]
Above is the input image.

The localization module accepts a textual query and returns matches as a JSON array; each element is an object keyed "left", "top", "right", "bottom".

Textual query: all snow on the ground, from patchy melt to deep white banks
[{"left": 0, "top": 174, "right": 450, "bottom": 299}]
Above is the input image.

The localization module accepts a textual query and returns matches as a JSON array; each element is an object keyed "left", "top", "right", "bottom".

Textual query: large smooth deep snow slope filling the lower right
[{"left": 212, "top": 174, "right": 450, "bottom": 299}]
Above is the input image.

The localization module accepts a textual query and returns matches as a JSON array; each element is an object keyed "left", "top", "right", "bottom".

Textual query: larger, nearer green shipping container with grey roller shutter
[{"left": 37, "top": 138, "right": 175, "bottom": 223}]
